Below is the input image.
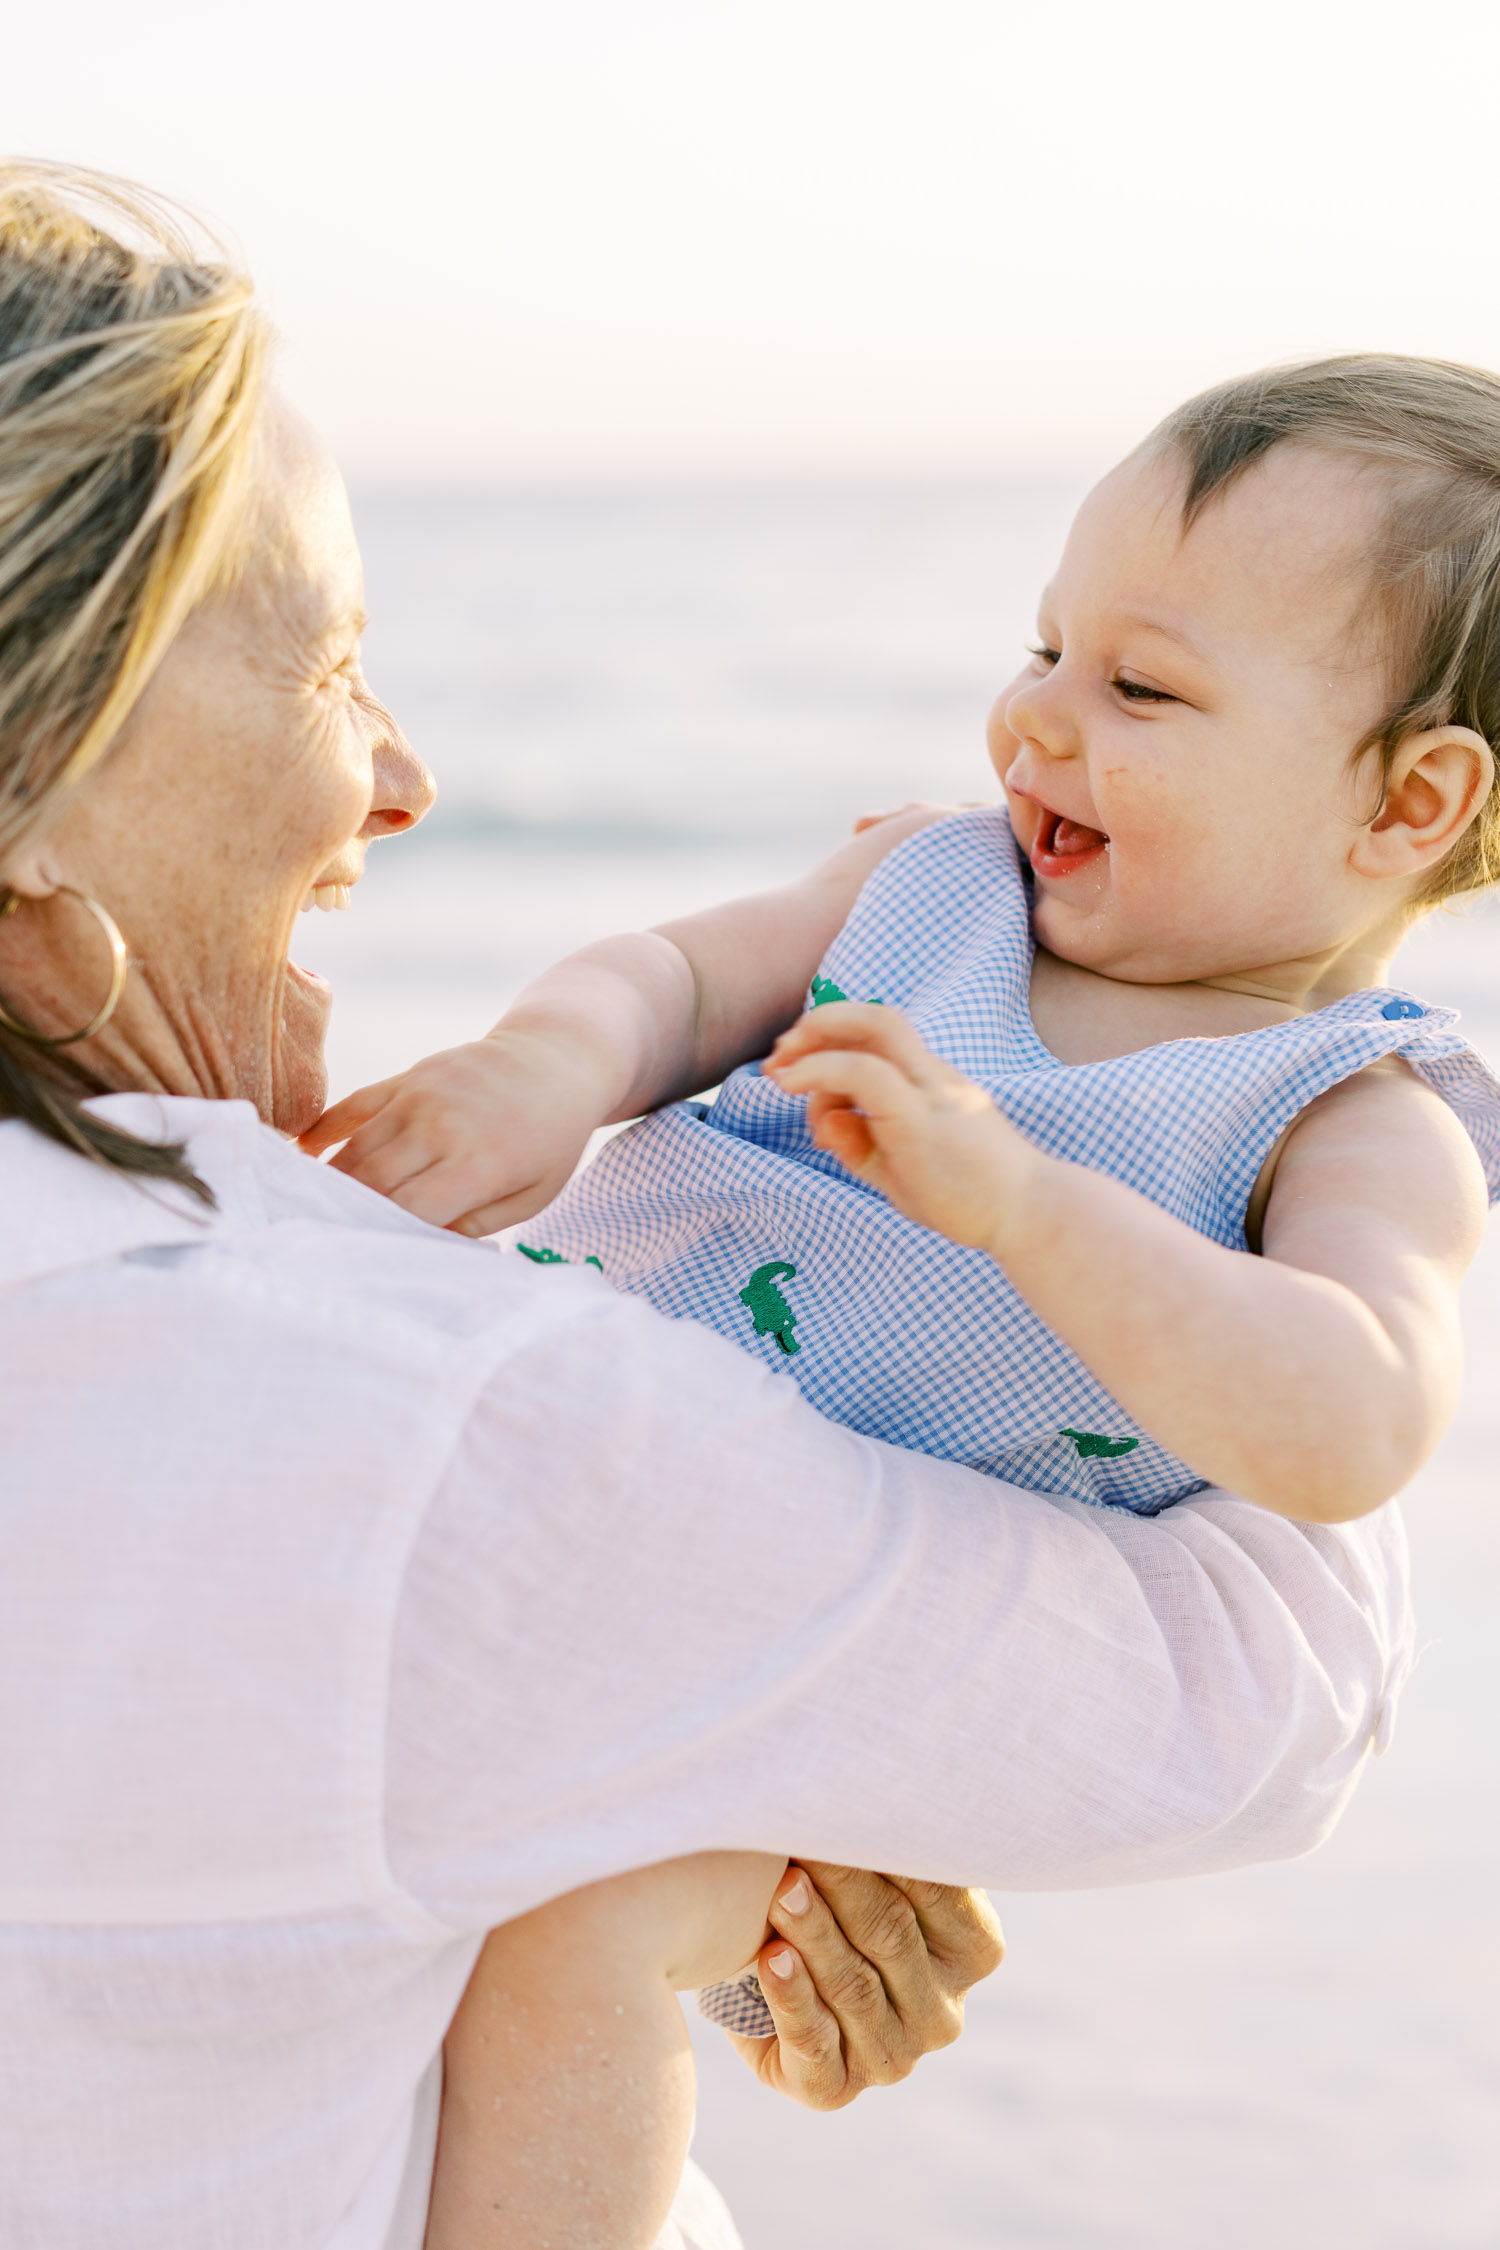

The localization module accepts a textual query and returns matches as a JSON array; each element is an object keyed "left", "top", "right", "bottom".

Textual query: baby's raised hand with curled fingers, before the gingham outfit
[{"left": 765, "top": 1001, "right": 1046, "bottom": 1256}]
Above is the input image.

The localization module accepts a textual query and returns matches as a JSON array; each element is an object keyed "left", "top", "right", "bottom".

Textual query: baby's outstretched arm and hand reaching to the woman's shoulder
[{"left": 301, "top": 806, "right": 954, "bottom": 1235}]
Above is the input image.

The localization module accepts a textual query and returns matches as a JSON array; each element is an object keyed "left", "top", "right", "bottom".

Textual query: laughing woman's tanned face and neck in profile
[{"left": 0, "top": 401, "right": 434, "bottom": 1134}]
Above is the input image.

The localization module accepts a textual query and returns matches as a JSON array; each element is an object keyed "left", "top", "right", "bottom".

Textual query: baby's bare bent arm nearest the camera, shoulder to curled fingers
[{"left": 767, "top": 1006, "right": 1487, "bottom": 1523}]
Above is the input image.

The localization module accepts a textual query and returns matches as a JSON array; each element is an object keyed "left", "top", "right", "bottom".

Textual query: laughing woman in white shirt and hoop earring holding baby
[{"left": 0, "top": 169, "right": 1408, "bottom": 2250}]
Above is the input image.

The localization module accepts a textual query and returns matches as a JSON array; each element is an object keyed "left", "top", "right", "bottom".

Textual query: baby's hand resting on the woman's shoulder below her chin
[{"left": 301, "top": 1031, "right": 605, "bottom": 1235}]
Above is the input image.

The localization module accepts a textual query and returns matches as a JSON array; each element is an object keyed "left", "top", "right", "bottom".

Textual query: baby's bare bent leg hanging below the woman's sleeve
[{"left": 427, "top": 1852, "right": 787, "bottom": 2250}]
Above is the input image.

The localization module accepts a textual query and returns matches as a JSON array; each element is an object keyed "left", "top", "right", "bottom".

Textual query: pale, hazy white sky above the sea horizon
[{"left": 0, "top": 0, "right": 1500, "bottom": 484}]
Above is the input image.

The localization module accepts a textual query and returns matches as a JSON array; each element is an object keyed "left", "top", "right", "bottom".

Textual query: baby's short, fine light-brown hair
[{"left": 1147, "top": 353, "right": 1500, "bottom": 907}]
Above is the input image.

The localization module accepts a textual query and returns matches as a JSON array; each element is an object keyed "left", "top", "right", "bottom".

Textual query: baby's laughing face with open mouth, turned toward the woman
[{"left": 990, "top": 446, "right": 1390, "bottom": 983}]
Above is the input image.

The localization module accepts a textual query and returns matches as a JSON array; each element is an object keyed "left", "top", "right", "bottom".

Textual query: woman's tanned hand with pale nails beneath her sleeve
[{"left": 735, "top": 1861, "right": 1005, "bottom": 2111}]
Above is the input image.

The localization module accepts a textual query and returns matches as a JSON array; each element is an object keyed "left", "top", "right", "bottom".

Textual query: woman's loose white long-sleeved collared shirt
[{"left": 0, "top": 1096, "right": 1410, "bottom": 2250}]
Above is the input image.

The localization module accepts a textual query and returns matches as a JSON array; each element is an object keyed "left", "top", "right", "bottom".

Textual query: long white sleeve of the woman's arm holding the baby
[{"left": 387, "top": 1292, "right": 1410, "bottom": 1928}]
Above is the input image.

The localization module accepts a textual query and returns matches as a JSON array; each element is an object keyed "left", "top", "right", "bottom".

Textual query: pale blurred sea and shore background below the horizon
[{"left": 297, "top": 484, "right": 1500, "bottom": 2250}]
